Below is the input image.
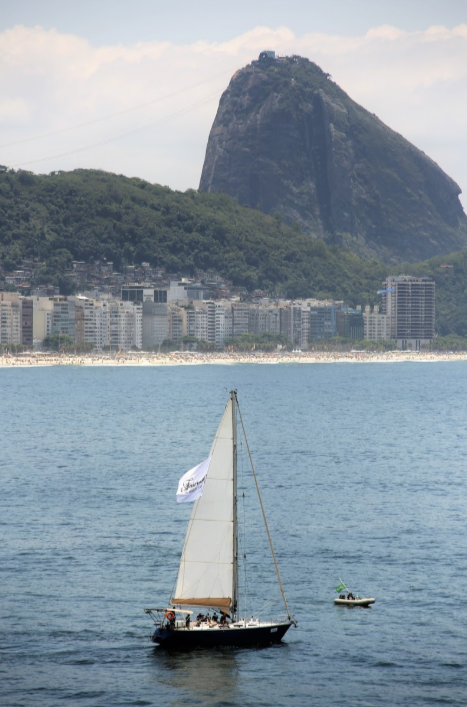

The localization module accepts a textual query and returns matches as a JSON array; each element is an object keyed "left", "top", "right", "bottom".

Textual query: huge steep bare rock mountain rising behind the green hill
[{"left": 200, "top": 57, "right": 467, "bottom": 262}]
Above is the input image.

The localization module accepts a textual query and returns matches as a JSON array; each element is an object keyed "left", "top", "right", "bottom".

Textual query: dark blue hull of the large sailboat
[{"left": 151, "top": 623, "right": 292, "bottom": 650}]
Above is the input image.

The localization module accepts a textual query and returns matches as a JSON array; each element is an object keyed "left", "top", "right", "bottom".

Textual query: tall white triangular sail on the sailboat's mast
[{"left": 172, "top": 400, "right": 234, "bottom": 607}]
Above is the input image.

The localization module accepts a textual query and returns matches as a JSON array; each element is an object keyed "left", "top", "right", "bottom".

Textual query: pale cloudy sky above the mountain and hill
[{"left": 0, "top": 0, "right": 467, "bottom": 209}]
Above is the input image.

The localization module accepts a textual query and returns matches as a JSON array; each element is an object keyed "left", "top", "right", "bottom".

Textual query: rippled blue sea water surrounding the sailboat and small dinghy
[{"left": 0, "top": 362, "right": 467, "bottom": 707}]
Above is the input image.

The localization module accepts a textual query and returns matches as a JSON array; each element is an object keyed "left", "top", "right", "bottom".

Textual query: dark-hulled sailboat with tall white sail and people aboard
[{"left": 144, "top": 390, "right": 297, "bottom": 650}]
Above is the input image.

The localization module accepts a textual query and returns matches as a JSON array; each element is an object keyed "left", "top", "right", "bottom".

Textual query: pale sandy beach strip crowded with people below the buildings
[{"left": 0, "top": 351, "right": 467, "bottom": 368}]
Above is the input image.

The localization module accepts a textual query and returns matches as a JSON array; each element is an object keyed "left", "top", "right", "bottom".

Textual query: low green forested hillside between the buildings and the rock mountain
[{"left": 0, "top": 170, "right": 467, "bottom": 336}]
